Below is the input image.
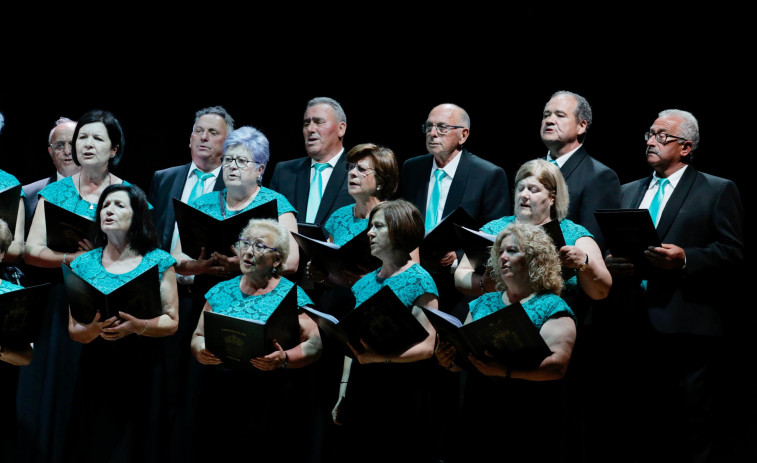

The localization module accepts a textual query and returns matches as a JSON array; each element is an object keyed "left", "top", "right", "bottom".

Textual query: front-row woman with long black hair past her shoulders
[{"left": 63, "top": 183, "right": 179, "bottom": 463}]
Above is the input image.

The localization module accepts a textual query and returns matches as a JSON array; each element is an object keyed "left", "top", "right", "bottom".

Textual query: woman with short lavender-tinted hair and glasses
[{"left": 172, "top": 126, "right": 300, "bottom": 277}]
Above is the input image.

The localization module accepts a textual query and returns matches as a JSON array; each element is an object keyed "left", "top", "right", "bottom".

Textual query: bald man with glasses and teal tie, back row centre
[{"left": 399, "top": 104, "right": 512, "bottom": 461}]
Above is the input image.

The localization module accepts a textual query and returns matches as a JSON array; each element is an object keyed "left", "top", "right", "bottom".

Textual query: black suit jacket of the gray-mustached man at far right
[{"left": 621, "top": 166, "right": 744, "bottom": 336}]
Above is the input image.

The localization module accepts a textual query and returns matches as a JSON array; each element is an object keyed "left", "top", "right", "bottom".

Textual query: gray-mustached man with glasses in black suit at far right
[{"left": 605, "top": 110, "right": 747, "bottom": 462}]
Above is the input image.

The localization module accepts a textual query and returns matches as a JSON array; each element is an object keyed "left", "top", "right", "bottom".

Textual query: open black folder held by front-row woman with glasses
[{"left": 203, "top": 286, "right": 300, "bottom": 368}]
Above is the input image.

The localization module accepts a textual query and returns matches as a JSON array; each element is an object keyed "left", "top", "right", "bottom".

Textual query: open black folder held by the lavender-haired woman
[{"left": 173, "top": 198, "right": 279, "bottom": 258}]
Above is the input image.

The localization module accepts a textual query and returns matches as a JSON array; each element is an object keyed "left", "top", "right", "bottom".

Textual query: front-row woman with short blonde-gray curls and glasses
[{"left": 191, "top": 219, "right": 321, "bottom": 461}]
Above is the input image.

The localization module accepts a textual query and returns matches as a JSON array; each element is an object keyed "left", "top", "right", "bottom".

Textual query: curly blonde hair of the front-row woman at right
[{"left": 486, "top": 221, "right": 563, "bottom": 296}]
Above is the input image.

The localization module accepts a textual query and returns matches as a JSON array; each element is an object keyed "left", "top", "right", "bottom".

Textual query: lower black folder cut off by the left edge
[{"left": 0, "top": 283, "right": 51, "bottom": 345}]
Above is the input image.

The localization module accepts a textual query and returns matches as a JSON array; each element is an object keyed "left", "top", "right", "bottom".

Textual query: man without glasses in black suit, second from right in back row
[{"left": 541, "top": 90, "right": 620, "bottom": 251}]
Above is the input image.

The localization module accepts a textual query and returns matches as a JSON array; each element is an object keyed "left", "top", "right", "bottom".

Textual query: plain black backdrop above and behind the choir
[{"left": 0, "top": 11, "right": 757, "bottom": 456}]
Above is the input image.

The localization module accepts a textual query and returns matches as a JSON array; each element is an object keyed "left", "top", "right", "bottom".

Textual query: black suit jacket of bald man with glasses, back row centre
[{"left": 399, "top": 150, "right": 513, "bottom": 226}]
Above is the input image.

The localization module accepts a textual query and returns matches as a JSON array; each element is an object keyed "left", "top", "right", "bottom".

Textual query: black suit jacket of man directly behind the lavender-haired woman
[{"left": 147, "top": 163, "right": 226, "bottom": 252}]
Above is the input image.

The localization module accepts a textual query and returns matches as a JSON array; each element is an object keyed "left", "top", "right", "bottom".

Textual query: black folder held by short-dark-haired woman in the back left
[{"left": 45, "top": 201, "right": 97, "bottom": 252}]
